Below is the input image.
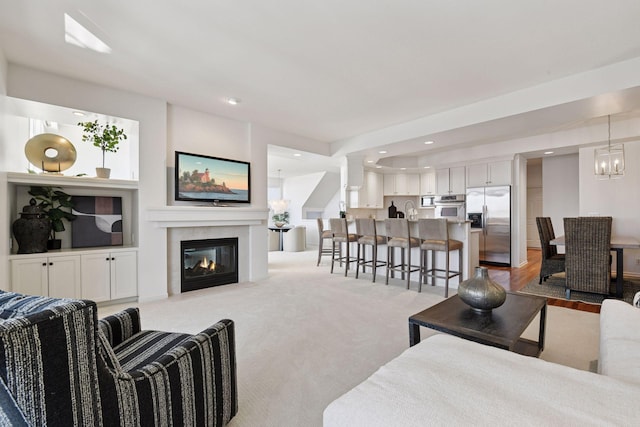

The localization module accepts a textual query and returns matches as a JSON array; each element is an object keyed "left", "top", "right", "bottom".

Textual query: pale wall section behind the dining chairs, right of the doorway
[{"left": 542, "top": 154, "right": 580, "bottom": 241}]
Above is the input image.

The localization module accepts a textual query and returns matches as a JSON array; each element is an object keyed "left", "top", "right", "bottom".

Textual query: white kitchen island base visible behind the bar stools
[{"left": 350, "top": 219, "right": 479, "bottom": 289}]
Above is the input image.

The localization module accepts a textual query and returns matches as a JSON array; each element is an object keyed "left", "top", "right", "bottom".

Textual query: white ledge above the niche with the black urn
[{"left": 7, "top": 172, "right": 138, "bottom": 190}]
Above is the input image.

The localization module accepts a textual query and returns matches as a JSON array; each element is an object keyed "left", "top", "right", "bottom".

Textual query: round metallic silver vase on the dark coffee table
[{"left": 458, "top": 267, "right": 507, "bottom": 313}]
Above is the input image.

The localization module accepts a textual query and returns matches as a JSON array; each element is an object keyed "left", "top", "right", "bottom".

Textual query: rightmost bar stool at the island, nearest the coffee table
[{"left": 418, "top": 218, "right": 462, "bottom": 298}]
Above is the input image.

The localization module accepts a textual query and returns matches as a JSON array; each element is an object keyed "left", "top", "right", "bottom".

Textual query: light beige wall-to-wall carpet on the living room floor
[{"left": 99, "top": 250, "right": 599, "bottom": 427}]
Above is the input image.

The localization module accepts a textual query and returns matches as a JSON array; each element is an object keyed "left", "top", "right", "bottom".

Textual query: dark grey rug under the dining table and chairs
[{"left": 519, "top": 276, "right": 640, "bottom": 304}]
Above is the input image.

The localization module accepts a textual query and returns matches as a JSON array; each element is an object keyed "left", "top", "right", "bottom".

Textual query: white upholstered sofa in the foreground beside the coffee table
[{"left": 323, "top": 300, "right": 640, "bottom": 427}]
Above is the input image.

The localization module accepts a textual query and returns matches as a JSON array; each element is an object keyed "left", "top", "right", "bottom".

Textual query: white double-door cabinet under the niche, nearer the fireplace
[{"left": 81, "top": 251, "right": 138, "bottom": 302}]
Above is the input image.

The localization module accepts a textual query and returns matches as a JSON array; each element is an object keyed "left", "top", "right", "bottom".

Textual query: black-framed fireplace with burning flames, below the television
[{"left": 180, "top": 237, "right": 238, "bottom": 292}]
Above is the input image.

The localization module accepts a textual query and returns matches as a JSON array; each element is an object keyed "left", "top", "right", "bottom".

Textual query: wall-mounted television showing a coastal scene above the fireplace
[{"left": 175, "top": 151, "right": 251, "bottom": 203}]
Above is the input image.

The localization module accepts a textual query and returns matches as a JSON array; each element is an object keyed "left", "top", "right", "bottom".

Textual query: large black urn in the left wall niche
[{"left": 12, "top": 199, "right": 51, "bottom": 254}]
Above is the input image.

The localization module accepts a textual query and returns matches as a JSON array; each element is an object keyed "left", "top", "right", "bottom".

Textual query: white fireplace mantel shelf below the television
[{"left": 146, "top": 206, "right": 269, "bottom": 228}]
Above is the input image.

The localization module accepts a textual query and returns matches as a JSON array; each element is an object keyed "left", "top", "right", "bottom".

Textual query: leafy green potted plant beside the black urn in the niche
[{"left": 29, "top": 186, "right": 76, "bottom": 249}]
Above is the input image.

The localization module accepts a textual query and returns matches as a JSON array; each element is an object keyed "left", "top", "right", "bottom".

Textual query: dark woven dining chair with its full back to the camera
[{"left": 564, "top": 217, "right": 612, "bottom": 299}]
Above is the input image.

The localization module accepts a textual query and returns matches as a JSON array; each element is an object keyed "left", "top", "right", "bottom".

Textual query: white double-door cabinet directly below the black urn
[{"left": 11, "top": 255, "right": 81, "bottom": 298}]
